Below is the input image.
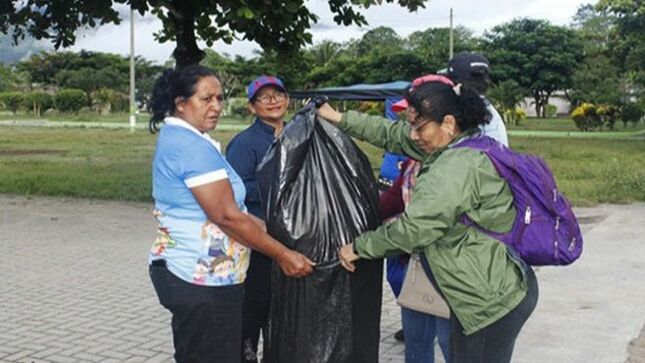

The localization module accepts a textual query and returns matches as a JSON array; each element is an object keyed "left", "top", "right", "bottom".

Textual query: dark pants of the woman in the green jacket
[{"left": 450, "top": 267, "right": 538, "bottom": 363}]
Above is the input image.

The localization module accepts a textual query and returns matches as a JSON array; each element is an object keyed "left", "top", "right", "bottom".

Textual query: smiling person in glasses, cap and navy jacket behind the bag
[{"left": 226, "top": 76, "right": 289, "bottom": 362}]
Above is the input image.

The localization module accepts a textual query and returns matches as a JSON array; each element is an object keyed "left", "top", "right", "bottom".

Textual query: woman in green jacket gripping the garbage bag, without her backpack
[{"left": 318, "top": 82, "right": 538, "bottom": 363}]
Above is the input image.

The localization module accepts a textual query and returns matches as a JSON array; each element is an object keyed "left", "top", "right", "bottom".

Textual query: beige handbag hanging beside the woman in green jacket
[{"left": 397, "top": 254, "right": 450, "bottom": 319}]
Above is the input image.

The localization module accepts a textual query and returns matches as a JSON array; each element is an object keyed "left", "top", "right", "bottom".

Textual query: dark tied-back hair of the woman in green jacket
[{"left": 405, "top": 82, "right": 492, "bottom": 131}]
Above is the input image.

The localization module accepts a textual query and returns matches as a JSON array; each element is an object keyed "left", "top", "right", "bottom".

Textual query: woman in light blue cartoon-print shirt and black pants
[{"left": 149, "top": 65, "right": 312, "bottom": 363}]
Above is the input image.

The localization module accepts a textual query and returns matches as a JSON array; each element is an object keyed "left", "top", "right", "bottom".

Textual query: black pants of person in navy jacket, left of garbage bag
[{"left": 242, "top": 251, "right": 273, "bottom": 363}]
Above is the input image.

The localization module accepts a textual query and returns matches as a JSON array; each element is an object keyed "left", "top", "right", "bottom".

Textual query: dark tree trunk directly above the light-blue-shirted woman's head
[{"left": 169, "top": 0, "right": 204, "bottom": 68}]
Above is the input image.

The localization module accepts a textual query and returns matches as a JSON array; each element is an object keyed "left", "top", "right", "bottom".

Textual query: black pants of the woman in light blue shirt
[{"left": 149, "top": 260, "right": 244, "bottom": 363}]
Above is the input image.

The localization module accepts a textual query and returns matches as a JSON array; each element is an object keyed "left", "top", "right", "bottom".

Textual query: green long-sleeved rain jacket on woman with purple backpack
[{"left": 339, "top": 111, "right": 527, "bottom": 335}]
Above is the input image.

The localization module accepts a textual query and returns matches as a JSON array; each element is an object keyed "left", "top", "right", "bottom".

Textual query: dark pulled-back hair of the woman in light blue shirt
[{"left": 148, "top": 65, "right": 217, "bottom": 134}]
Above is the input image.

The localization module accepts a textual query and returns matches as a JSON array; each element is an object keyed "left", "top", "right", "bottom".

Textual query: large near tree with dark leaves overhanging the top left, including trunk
[{"left": 0, "top": 0, "right": 427, "bottom": 66}]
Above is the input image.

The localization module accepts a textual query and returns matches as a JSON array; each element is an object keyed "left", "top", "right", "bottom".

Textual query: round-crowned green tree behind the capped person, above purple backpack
[{"left": 484, "top": 19, "right": 583, "bottom": 117}]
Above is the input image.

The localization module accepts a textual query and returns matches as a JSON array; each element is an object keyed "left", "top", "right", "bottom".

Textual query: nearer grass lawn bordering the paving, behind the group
[{"left": 0, "top": 126, "right": 645, "bottom": 205}]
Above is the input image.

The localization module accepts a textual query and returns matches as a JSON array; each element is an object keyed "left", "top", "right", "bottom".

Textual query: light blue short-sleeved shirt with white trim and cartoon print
[{"left": 149, "top": 117, "right": 250, "bottom": 286}]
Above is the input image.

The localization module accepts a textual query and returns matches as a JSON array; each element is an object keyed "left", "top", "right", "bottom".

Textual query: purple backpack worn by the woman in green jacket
[{"left": 454, "top": 136, "right": 582, "bottom": 265}]
